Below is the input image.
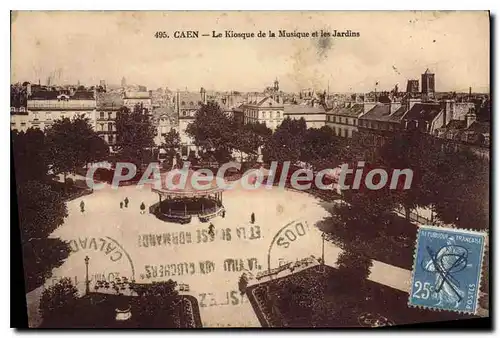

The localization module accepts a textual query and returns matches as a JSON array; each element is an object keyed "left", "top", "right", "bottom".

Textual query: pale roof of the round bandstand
[{"left": 151, "top": 170, "right": 224, "bottom": 198}]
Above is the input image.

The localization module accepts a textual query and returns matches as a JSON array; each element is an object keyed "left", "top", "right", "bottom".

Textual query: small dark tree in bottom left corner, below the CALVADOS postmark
[{"left": 40, "top": 278, "right": 78, "bottom": 328}]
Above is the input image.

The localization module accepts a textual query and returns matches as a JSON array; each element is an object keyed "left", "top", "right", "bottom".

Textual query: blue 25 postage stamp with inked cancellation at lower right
[{"left": 408, "top": 226, "right": 486, "bottom": 314}]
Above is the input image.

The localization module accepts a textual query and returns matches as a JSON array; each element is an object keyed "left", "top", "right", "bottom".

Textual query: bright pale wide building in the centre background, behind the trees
[{"left": 242, "top": 96, "right": 285, "bottom": 130}]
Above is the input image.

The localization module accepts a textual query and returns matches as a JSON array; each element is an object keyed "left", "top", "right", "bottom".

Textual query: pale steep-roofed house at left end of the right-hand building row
[{"left": 326, "top": 102, "right": 364, "bottom": 137}]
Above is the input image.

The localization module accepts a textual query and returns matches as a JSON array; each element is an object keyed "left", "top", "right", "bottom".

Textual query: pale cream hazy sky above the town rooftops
[{"left": 12, "top": 12, "right": 489, "bottom": 92}]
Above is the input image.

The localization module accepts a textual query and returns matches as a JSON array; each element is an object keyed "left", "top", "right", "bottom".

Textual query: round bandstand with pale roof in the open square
[{"left": 150, "top": 170, "right": 225, "bottom": 224}]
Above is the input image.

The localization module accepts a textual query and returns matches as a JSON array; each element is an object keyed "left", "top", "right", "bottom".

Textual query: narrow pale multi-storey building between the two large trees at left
[{"left": 95, "top": 93, "right": 124, "bottom": 151}]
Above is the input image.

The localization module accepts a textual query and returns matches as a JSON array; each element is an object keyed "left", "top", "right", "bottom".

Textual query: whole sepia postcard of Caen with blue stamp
[{"left": 10, "top": 11, "right": 491, "bottom": 328}]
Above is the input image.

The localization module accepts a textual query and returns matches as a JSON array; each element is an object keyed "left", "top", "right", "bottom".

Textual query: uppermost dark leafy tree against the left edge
[{"left": 11, "top": 128, "right": 49, "bottom": 183}]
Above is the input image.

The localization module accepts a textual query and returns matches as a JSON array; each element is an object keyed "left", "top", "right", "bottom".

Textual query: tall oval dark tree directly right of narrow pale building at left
[{"left": 116, "top": 105, "right": 156, "bottom": 168}]
